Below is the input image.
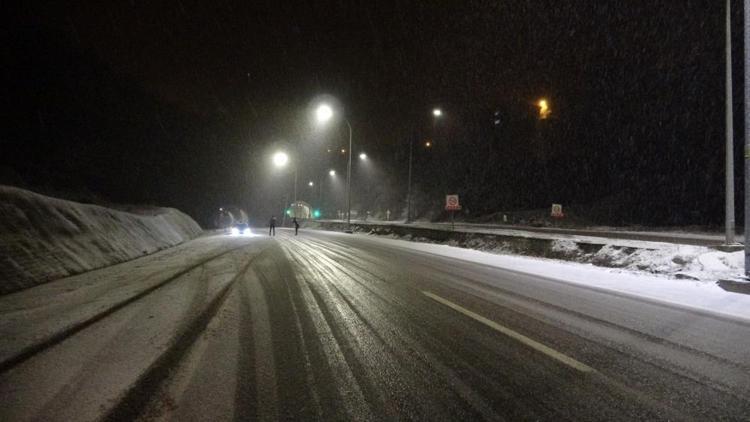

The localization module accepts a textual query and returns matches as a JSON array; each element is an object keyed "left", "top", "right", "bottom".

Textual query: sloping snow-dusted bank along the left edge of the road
[{"left": 0, "top": 185, "right": 202, "bottom": 294}]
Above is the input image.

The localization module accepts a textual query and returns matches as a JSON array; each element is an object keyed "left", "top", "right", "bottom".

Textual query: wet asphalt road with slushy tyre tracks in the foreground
[{"left": 0, "top": 230, "right": 750, "bottom": 421}]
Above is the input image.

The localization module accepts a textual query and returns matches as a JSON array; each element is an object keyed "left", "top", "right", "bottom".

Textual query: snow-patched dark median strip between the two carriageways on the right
[{"left": 308, "top": 222, "right": 744, "bottom": 282}]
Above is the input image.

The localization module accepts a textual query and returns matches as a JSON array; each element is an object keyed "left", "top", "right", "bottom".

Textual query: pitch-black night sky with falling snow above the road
[{"left": 0, "top": 0, "right": 744, "bottom": 226}]
